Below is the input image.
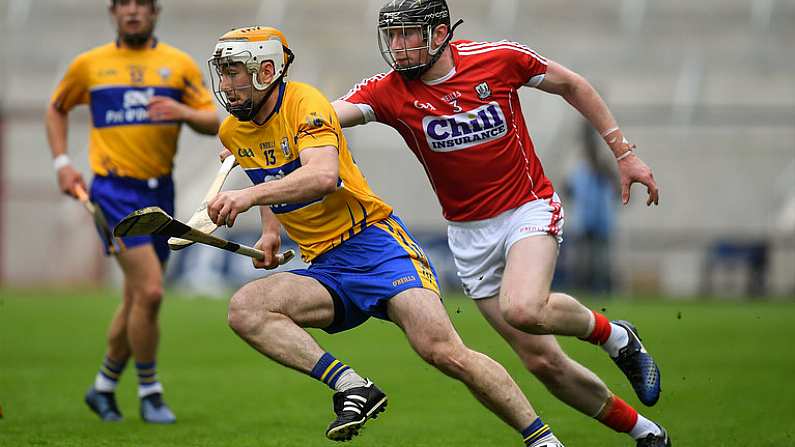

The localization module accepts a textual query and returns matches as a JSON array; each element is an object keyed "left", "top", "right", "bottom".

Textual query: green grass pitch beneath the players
[{"left": 0, "top": 290, "right": 795, "bottom": 447}]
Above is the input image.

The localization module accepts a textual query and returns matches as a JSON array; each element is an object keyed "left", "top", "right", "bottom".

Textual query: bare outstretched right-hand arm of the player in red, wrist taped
[{"left": 537, "top": 61, "right": 659, "bottom": 206}]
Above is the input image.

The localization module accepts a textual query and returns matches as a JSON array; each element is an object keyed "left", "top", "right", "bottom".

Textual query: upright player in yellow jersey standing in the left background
[{"left": 45, "top": 0, "right": 218, "bottom": 423}]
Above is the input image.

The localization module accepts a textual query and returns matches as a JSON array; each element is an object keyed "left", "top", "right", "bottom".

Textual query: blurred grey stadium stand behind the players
[{"left": 0, "top": 0, "right": 795, "bottom": 296}]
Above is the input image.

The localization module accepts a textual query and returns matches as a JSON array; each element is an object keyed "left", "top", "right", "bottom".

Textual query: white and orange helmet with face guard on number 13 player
[{"left": 207, "top": 27, "right": 295, "bottom": 121}]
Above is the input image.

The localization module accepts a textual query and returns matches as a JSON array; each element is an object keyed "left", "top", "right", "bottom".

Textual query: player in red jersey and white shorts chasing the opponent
[{"left": 334, "top": 0, "right": 670, "bottom": 447}]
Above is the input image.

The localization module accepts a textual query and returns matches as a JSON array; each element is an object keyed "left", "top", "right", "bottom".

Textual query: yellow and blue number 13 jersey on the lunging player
[{"left": 218, "top": 82, "right": 392, "bottom": 262}]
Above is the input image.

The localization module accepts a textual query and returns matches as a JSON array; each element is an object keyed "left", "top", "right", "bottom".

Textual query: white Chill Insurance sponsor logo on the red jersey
[{"left": 422, "top": 102, "right": 508, "bottom": 152}]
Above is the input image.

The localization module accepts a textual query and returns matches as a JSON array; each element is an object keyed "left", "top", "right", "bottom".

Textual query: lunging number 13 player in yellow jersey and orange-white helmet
[{"left": 208, "top": 27, "right": 558, "bottom": 446}]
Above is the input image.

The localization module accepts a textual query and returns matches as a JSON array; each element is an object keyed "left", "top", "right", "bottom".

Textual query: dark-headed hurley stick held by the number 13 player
[{"left": 113, "top": 206, "right": 295, "bottom": 265}]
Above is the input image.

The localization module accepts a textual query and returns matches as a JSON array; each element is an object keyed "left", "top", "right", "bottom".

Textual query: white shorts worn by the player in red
[{"left": 447, "top": 194, "right": 563, "bottom": 299}]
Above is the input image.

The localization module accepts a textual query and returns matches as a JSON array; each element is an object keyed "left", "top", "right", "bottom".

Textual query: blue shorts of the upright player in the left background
[{"left": 91, "top": 175, "right": 174, "bottom": 262}]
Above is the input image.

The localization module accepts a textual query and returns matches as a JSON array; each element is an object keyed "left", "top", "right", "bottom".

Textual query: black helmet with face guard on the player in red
[{"left": 378, "top": 0, "right": 463, "bottom": 79}]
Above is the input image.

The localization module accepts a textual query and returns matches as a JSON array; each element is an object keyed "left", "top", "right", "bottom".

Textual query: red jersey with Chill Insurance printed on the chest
[{"left": 340, "top": 41, "right": 554, "bottom": 222}]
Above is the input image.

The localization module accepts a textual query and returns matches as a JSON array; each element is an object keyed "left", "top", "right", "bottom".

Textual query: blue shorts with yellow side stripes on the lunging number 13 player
[{"left": 290, "top": 215, "right": 439, "bottom": 334}]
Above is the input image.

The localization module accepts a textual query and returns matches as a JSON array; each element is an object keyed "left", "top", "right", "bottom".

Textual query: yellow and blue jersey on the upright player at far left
[{"left": 51, "top": 41, "right": 215, "bottom": 179}]
